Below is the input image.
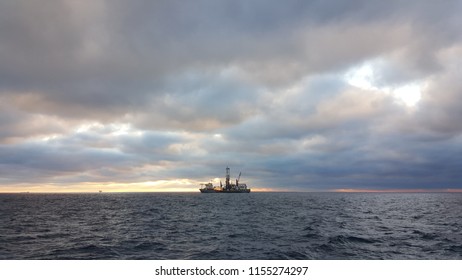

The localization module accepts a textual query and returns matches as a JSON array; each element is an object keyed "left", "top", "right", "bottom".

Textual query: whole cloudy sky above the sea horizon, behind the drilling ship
[{"left": 0, "top": 0, "right": 462, "bottom": 192}]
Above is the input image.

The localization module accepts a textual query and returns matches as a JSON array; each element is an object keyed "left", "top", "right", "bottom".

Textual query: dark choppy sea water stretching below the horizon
[{"left": 0, "top": 193, "right": 462, "bottom": 260}]
